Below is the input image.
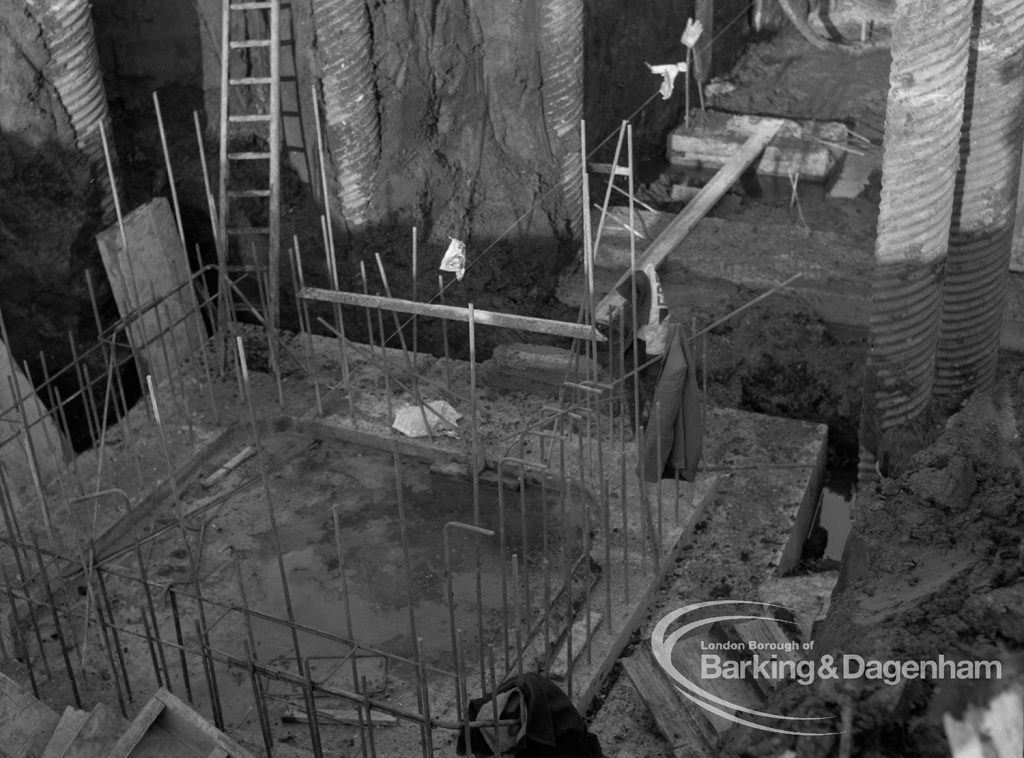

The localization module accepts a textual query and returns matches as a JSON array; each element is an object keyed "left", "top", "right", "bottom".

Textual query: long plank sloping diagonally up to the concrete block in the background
[{"left": 595, "top": 119, "right": 783, "bottom": 324}]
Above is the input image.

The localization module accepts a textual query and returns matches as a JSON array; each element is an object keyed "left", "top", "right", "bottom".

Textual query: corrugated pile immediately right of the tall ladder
[{"left": 313, "top": 0, "right": 381, "bottom": 227}]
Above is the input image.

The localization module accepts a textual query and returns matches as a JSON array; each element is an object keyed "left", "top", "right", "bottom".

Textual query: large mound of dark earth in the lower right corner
[{"left": 722, "top": 381, "right": 1024, "bottom": 757}]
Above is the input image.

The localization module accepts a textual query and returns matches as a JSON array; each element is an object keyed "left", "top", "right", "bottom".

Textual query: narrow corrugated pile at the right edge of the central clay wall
[{"left": 539, "top": 0, "right": 584, "bottom": 239}]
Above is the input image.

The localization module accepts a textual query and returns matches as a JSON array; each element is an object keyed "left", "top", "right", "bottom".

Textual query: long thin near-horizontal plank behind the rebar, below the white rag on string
[{"left": 299, "top": 284, "right": 606, "bottom": 342}]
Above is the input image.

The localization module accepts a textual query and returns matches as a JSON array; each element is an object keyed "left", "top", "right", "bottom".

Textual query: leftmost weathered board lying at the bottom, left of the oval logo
[{"left": 623, "top": 644, "right": 713, "bottom": 758}]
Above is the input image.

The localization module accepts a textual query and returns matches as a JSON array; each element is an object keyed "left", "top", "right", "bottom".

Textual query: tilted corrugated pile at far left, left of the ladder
[{"left": 28, "top": 0, "right": 115, "bottom": 221}]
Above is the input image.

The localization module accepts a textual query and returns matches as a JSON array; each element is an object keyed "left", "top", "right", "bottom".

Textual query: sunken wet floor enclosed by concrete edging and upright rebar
[{"left": 75, "top": 419, "right": 592, "bottom": 730}]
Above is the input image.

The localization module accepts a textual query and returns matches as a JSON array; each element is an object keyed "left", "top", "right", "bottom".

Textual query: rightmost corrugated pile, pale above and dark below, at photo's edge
[{"left": 934, "top": 0, "right": 1024, "bottom": 408}]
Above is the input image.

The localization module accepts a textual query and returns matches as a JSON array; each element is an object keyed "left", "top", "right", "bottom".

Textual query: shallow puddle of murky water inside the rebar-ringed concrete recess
[{"left": 251, "top": 450, "right": 582, "bottom": 670}]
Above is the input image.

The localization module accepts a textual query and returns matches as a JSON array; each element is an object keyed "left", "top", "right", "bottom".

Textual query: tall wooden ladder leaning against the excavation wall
[{"left": 217, "top": 0, "right": 281, "bottom": 329}]
